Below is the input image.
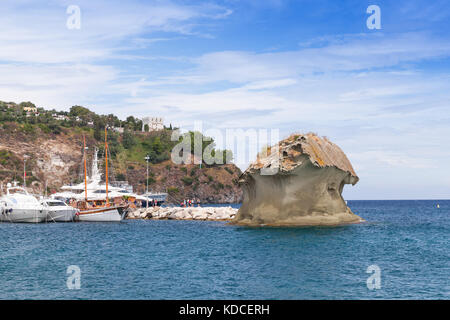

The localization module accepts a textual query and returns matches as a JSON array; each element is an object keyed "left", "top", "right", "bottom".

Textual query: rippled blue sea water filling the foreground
[{"left": 0, "top": 200, "right": 450, "bottom": 299}]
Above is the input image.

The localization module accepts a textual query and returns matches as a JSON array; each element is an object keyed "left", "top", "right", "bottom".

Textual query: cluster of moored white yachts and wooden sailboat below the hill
[{"left": 0, "top": 127, "right": 167, "bottom": 223}]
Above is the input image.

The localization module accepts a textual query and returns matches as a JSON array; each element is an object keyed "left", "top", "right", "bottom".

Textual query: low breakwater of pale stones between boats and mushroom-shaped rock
[{"left": 128, "top": 207, "right": 238, "bottom": 221}]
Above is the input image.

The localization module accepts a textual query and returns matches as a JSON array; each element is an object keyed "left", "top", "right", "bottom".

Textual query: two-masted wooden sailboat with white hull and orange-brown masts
[{"left": 75, "top": 127, "right": 127, "bottom": 222}]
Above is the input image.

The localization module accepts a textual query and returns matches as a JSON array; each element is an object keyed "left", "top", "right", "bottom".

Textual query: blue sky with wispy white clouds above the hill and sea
[{"left": 0, "top": 0, "right": 450, "bottom": 199}]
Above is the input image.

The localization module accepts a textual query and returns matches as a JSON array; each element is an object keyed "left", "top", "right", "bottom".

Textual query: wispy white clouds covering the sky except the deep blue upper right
[{"left": 0, "top": 1, "right": 450, "bottom": 199}]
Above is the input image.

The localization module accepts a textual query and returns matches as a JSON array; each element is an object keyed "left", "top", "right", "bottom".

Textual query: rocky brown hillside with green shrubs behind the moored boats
[{"left": 0, "top": 102, "right": 242, "bottom": 203}]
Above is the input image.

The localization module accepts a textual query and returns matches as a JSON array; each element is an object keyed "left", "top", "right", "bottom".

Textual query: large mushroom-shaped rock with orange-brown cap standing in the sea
[{"left": 233, "top": 133, "right": 362, "bottom": 226}]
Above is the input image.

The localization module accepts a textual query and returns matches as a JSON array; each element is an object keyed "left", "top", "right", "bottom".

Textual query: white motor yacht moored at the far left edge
[{"left": 0, "top": 184, "right": 47, "bottom": 223}]
